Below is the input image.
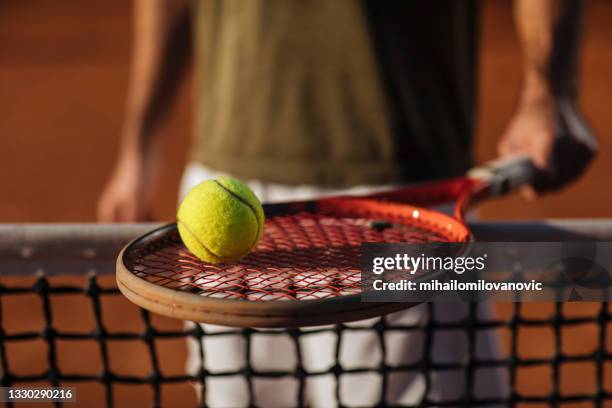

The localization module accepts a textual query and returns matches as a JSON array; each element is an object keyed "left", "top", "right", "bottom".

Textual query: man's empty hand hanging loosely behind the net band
[{"left": 97, "top": 156, "right": 153, "bottom": 222}]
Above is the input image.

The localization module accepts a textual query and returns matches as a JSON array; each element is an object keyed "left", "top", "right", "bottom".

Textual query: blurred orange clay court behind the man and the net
[{"left": 0, "top": 0, "right": 612, "bottom": 406}]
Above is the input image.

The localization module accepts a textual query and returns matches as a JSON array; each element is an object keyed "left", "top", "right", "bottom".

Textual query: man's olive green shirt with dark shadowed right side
[{"left": 192, "top": 0, "right": 476, "bottom": 187}]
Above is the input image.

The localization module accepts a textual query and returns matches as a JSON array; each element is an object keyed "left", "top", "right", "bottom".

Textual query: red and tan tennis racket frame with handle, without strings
[{"left": 116, "top": 157, "right": 534, "bottom": 328}]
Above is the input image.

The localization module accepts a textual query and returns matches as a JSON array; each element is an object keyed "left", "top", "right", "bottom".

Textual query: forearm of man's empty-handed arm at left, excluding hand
[{"left": 121, "top": 0, "right": 190, "bottom": 154}]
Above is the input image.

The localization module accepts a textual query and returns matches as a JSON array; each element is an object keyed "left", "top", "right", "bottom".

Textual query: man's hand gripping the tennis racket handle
[{"left": 498, "top": 96, "right": 597, "bottom": 198}]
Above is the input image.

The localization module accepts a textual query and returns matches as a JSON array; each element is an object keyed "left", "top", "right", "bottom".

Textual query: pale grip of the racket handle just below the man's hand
[{"left": 467, "top": 156, "right": 537, "bottom": 196}]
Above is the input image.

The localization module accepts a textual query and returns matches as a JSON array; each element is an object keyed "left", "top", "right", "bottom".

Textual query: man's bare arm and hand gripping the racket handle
[{"left": 499, "top": 0, "right": 597, "bottom": 196}]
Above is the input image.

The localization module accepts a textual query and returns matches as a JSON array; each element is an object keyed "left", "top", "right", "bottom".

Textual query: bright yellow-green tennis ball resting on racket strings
[{"left": 177, "top": 177, "right": 264, "bottom": 263}]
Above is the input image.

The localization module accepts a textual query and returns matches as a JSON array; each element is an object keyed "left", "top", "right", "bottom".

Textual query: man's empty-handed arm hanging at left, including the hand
[{"left": 98, "top": 0, "right": 190, "bottom": 222}]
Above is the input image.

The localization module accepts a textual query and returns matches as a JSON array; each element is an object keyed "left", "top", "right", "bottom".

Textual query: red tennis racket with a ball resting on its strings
[{"left": 117, "top": 158, "right": 535, "bottom": 328}]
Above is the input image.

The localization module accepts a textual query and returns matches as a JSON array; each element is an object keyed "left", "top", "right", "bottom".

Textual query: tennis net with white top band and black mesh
[{"left": 0, "top": 225, "right": 612, "bottom": 407}]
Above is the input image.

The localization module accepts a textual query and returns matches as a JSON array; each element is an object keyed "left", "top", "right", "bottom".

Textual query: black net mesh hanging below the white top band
[{"left": 0, "top": 273, "right": 612, "bottom": 407}]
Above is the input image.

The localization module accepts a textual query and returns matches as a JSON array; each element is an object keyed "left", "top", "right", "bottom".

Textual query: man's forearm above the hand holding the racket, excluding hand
[{"left": 515, "top": 0, "right": 584, "bottom": 100}]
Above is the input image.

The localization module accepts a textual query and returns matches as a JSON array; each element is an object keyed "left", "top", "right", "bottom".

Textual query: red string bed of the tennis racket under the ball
[{"left": 129, "top": 211, "right": 449, "bottom": 301}]
